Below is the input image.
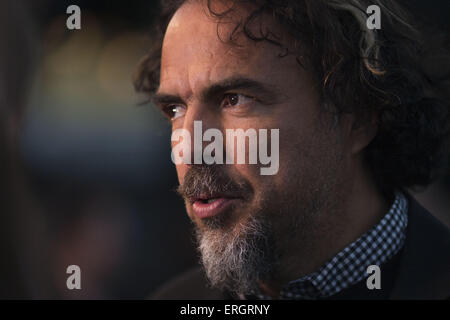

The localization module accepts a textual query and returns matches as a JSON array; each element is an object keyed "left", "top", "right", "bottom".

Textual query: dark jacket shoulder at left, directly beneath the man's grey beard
[{"left": 150, "top": 267, "right": 226, "bottom": 300}]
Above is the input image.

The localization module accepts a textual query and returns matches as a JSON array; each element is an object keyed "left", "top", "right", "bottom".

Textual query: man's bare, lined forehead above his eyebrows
[{"left": 160, "top": 1, "right": 306, "bottom": 97}]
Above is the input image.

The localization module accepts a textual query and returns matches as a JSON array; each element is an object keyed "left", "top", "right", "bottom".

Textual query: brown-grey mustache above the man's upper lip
[{"left": 176, "top": 165, "right": 251, "bottom": 201}]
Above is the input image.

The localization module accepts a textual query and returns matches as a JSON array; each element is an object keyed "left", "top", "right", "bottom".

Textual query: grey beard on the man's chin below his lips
[{"left": 196, "top": 216, "right": 277, "bottom": 295}]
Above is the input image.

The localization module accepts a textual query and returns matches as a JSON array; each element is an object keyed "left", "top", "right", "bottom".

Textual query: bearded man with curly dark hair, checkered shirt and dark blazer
[{"left": 136, "top": 0, "right": 450, "bottom": 299}]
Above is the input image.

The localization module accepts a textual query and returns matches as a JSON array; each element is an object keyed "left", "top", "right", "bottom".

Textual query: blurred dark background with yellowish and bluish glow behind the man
[{"left": 0, "top": 0, "right": 450, "bottom": 299}]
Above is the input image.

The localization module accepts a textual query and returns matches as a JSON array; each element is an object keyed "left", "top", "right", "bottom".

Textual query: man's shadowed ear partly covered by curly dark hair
[{"left": 349, "top": 114, "right": 378, "bottom": 154}]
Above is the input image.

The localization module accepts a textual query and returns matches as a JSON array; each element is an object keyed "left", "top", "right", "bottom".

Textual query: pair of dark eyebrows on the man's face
[{"left": 152, "top": 76, "right": 279, "bottom": 105}]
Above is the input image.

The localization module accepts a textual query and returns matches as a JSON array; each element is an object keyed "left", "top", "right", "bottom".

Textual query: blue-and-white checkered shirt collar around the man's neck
[{"left": 257, "top": 192, "right": 408, "bottom": 299}]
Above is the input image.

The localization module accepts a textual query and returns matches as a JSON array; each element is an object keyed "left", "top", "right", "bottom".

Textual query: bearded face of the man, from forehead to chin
[{"left": 155, "top": 1, "right": 354, "bottom": 291}]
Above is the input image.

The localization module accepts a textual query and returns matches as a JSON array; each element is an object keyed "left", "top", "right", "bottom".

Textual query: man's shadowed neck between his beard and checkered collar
[{"left": 261, "top": 156, "right": 389, "bottom": 298}]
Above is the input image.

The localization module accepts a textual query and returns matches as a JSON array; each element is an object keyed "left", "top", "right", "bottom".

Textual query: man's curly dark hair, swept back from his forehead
[{"left": 135, "top": 0, "right": 450, "bottom": 193}]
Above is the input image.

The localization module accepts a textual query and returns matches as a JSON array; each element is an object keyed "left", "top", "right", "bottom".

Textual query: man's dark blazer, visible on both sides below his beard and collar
[{"left": 151, "top": 196, "right": 450, "bottom": 300}]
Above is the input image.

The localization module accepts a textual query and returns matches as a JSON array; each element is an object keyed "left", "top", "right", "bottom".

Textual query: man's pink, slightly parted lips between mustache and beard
[{"left": 191, "top": 195, "right": 240, "bottom": 219}]
